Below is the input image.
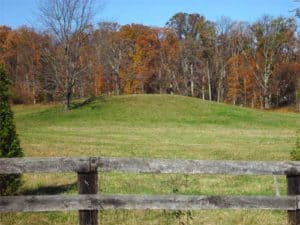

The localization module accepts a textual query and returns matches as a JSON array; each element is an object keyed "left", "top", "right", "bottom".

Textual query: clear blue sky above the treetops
[{"left": 0, "top": 0, "right": 299, "bottom": 28}]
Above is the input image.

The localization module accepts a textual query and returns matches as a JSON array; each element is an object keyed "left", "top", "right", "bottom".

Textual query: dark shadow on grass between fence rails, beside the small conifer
[{"left": 20, "top": 182, "right": 77, "bottom": 195}]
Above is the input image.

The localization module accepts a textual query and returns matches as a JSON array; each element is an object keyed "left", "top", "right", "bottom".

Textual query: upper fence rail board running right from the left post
[{"left": 97, "top": 158, "right": 300, "bottom": 175}]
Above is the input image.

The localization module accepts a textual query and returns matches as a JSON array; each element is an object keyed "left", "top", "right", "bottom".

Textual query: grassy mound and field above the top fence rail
[{"left": 15, "top": 95, "right": 300, "bottom": 160}]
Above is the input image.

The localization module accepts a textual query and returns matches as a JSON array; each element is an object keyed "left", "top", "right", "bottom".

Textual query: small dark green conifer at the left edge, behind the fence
[{"left": 0, "top": 64, "right": 23, "bottom": 195}]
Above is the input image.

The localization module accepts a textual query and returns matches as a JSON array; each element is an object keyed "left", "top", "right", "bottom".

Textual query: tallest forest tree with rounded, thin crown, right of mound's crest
[{"left": 167, "top": 13, "right": 215, "bottom": 100}]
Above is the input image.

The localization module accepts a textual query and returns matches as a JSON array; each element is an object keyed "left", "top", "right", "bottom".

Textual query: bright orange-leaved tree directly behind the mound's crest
[{"left": 110, "top": 24, "right": 160, "bottom": 93}]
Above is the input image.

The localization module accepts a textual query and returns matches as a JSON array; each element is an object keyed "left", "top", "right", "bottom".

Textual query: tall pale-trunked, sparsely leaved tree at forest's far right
[{"left": 252, "top": 16, "right": 296, "bottom": 109}]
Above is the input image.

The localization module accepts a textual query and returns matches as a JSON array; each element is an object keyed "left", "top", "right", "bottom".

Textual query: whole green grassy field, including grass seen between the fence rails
[{"left": 0, "top": 95, "right": 300, "bottom": 225}]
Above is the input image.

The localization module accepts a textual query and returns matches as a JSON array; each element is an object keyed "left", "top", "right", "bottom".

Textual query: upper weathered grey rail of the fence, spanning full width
[{"left": 0, "top": 157, "right": 300, "bottom": 175}]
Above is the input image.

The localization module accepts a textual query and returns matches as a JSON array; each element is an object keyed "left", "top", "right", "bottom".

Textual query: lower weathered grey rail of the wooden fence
[{"left": 0, "top": 195, "right": 299, "bottom": 212}]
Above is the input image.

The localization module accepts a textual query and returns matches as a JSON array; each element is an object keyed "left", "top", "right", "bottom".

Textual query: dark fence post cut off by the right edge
[{"left": 286, "top": 174, "right": 300, "bottom": 225}]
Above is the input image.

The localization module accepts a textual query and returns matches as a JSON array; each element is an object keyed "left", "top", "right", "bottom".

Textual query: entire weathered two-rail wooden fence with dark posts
[{"left": 0, "top": 157, "right": 300, "bottom": 225}]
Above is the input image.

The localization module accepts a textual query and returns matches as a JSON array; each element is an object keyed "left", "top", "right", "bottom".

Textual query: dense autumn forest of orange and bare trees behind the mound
[{"left": 0, "top": 12, "right": 300, "bottom": 109}]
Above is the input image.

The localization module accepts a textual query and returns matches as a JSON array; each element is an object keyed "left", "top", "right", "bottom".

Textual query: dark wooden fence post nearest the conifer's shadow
[{"left": 77, "top": 158, "right": 98, "bottom": 225}]
